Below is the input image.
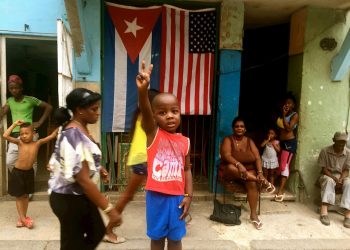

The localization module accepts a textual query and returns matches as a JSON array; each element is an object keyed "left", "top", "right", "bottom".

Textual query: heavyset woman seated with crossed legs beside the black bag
[{"left": 220, "top": 117, "right": 275, "bottom": 230}]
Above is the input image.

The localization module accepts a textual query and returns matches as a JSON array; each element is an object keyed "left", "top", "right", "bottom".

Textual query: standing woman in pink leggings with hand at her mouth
[{"left": 275, "top": 92, "right": 299, "bottom": 202}]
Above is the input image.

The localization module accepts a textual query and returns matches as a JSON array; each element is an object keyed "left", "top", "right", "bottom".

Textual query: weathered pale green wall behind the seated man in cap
[{"left": 288, "top": 8, "right": 350, "bottom": 201}]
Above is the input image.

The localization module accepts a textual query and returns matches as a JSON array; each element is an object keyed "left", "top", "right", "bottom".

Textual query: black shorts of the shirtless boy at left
[{"left": 8, "top": 168, "right": 34, "bottom": 197}]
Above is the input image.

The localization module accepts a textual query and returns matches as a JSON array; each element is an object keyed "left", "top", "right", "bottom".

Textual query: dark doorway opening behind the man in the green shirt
[{"left": 6, "top": 37, "right": 58, "bottom": 192}]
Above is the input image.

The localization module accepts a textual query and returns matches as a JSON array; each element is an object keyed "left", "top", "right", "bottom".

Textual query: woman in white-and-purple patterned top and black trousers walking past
[{"left": 49, "top": 88, "right": 125, "bottom": 250}]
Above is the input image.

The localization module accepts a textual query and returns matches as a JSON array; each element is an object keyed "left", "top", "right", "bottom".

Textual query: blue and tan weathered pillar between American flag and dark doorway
[{"left": 211, "top": 0, "right": 244, "bottom": 190}]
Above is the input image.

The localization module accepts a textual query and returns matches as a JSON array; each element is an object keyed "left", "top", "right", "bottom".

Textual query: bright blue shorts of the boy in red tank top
[{"left": 146, "top": 191, "right": 186, "bottom": 241}]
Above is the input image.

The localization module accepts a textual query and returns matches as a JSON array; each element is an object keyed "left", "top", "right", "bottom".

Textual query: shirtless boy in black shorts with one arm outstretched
[{"left": 3, "top": 120, "right": 58, "bottom": 229}]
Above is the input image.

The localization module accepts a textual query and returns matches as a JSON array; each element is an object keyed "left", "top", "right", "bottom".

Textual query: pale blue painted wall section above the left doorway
[{"left": 0, "top": 0, "right": 66, "bottom": 37}]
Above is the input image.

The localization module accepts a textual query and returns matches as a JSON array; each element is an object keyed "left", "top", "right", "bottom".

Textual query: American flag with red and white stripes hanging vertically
[{"left": 160, "top": 5, "right": 216, "bottom": 115}]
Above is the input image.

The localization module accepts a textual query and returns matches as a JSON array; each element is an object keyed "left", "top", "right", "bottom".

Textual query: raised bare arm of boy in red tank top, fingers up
[{"left": 136, "top": 61, "right": 156, "bottom": 135}]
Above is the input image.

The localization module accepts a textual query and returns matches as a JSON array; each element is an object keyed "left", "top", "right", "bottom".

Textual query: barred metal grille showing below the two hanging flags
[{"left": 102, "top": 115, "right": 211, "bottom": 191}]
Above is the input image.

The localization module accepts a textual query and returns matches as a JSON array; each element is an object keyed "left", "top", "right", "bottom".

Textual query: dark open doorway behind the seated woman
[{"left": 239, "top": 23, "right": 289, "bottom": 145}]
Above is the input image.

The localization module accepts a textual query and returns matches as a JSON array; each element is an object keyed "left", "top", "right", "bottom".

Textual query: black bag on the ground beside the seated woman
[{"left": 209, "top": 199, "right": 241, "bottom": 225}]
